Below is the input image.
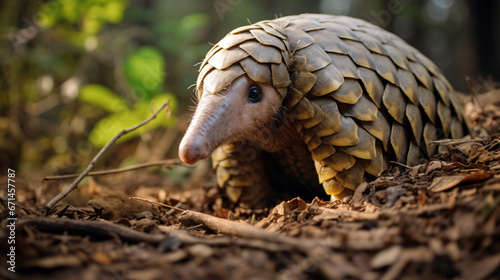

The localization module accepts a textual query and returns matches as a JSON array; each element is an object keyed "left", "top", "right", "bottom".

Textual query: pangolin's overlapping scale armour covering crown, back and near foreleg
[{"left": 198, "top": 14, "right": 466, "bottom": 203}]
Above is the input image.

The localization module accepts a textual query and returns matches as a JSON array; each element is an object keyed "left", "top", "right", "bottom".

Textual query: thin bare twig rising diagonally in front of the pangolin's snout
[{"left": 45, "top": 100, "right": 170, "bottom": 214}]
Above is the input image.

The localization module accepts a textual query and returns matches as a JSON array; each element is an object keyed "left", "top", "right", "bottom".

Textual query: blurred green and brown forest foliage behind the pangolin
[{"left": 0, "top": 0, "right": 500, "bottom": 176}]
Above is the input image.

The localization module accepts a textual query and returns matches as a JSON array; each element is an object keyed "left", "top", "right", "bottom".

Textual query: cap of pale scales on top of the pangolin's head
[{"left": 197, "top": 21, "right": 292, "bottom": 98}]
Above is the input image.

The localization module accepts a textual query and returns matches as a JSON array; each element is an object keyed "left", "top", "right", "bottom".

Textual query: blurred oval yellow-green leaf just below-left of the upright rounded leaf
[{"left": 78, "top": 84, "right": 129, "bottom": 113}]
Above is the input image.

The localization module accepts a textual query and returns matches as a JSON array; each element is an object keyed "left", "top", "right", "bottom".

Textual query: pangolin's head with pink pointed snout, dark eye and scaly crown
[{"left": 179, "top": 21, "right": 291, "bottom": 164}]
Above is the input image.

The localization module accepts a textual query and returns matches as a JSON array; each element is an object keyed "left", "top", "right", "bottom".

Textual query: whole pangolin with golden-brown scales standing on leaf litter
[{"left": 179, "top": 14, "right": 467, "bottom": 207}]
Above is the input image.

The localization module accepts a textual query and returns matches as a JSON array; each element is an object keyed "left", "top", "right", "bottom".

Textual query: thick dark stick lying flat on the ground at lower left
[{"left": 19, "top": 217, "right": 167, "bottom": 244}]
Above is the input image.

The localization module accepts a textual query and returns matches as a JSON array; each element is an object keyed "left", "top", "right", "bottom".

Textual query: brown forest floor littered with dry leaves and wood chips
[{"left": 0, "top": 91, "right": 500, "bottom": 280}]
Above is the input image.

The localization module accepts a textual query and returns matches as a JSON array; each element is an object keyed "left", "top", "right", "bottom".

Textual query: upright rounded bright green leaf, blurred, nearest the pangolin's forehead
[{"left": 123, "top": 47, "right": 165, "bottom": 100}]
